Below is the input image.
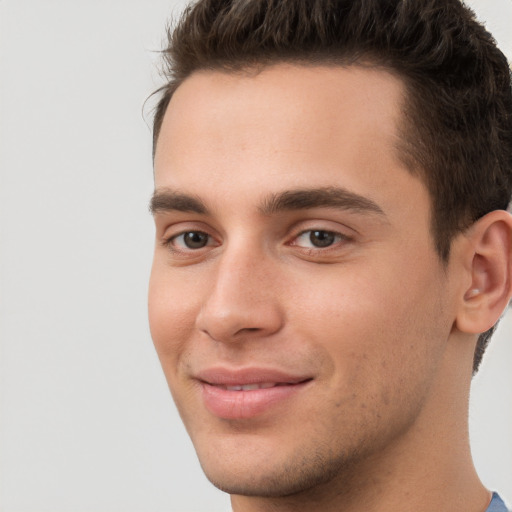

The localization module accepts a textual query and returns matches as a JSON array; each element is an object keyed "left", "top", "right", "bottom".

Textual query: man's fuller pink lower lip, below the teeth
[{"left": 201, "top": 381, "right": 310, "bottom": 420}]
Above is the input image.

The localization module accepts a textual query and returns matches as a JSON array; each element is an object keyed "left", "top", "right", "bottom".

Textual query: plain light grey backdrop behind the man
[{"left": 0, "top": 0, "right": 512, "bottom": 512}]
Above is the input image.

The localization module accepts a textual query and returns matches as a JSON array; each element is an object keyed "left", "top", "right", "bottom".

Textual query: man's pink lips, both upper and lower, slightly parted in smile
[{"left": 195, "top": 368, "right": 312, "bottom": 419}]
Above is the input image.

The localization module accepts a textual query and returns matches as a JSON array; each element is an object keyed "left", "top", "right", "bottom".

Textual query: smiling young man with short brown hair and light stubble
[{"left": 149, "top": 0, "right": 512, "bottom": 512}]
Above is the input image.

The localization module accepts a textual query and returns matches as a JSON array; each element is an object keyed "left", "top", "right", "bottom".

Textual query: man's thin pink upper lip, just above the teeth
[{"left": 194, "top": 367, "right": 312, "bottom": 386}]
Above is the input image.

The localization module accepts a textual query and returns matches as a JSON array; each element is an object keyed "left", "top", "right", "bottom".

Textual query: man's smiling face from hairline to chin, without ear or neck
[{"left": 149, "top": 65, "right": 454, "bottom": 496}]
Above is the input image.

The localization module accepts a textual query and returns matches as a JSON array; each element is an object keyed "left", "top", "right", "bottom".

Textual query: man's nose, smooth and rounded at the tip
[{"left": 196, "top": 244, "right": 284, "bottom": 343}]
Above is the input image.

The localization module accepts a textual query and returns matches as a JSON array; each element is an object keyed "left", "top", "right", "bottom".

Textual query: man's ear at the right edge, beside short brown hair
[{"left": 456, "top": 210, "right": 512, "bottom": 334}]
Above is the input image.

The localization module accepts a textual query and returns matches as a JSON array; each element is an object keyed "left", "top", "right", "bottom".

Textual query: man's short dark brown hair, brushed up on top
[{"left": 153, "top": 0, "right": 512, "bottom": 372}]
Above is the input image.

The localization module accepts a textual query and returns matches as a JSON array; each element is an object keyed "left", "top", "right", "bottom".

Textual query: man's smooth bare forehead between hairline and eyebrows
[{"left": 155, "top": 64, "right": 424, "bottom": 216}]
